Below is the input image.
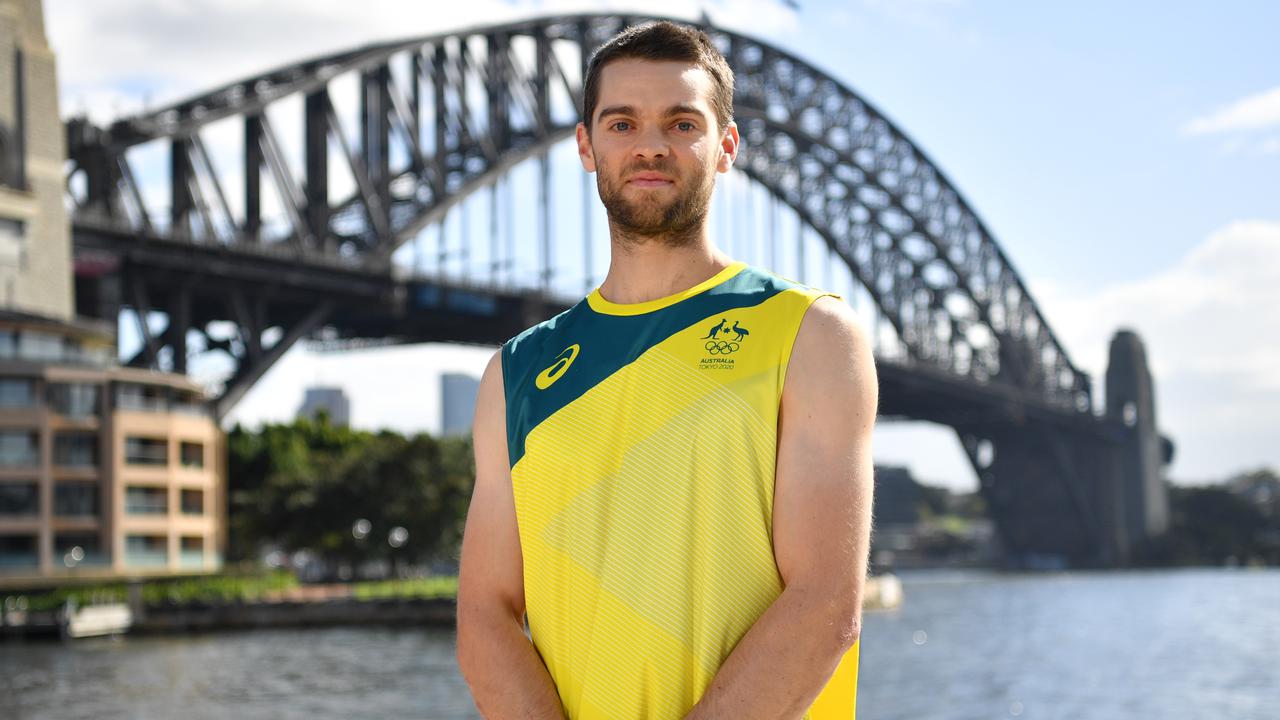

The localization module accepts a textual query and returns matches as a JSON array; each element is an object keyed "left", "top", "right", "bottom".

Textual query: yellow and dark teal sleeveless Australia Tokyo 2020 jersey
[{"left": 502, "top": 263, "right": 859, "bottom": 720}]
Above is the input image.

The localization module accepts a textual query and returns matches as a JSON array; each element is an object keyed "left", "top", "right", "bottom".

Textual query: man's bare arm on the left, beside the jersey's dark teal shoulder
[{"left": 458, "top": 350, "right": 564, "bottom": 720}]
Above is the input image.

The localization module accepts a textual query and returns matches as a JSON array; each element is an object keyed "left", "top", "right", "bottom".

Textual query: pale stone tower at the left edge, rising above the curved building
[{"left": 0, "top": 0, "right": 74, "bottom": 320}]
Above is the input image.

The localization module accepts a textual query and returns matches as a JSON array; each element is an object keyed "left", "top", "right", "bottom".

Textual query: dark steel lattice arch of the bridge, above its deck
[{"left": 68, "top": 14, "right": 1092, "bottom": 414}]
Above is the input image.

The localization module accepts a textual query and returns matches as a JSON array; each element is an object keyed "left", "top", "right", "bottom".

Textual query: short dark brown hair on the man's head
[{"left": 582, "top": 20, "right": 733, "bottom": 133}]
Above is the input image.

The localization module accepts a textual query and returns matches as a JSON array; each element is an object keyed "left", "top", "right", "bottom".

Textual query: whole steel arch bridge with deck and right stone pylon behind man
[{"left": 67, "top": 14, "right": 1171, "bottom": 566}]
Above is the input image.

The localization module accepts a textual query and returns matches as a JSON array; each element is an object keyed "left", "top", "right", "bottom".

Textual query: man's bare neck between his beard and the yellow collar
[{"left": 600, "top": 223, "right": 733, "bottom": 305}]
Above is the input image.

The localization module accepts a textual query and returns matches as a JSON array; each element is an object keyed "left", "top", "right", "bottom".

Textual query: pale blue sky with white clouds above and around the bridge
[{"left": 45, "top": 0, "right": 1280, "bottom": 489}]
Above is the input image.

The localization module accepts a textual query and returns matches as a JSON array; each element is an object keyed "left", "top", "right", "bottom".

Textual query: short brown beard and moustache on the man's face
[{"left": 595, "top": 151, "right": 716, "bottom": 247}]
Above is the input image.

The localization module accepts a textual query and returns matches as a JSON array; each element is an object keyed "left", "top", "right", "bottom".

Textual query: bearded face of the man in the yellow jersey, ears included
[{"left": 577, "top": 59, "right": 739, "bottom": 245}]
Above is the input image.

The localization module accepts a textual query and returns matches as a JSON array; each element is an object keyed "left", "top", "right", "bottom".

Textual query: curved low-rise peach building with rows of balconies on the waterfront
[{"left": 0, "top": 311, "right": 227, "bottom": 587}]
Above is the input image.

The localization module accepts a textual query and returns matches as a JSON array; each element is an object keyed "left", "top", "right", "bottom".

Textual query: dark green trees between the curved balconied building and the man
[{"left": 228, "top": 416, "right": 475, "bottom": 564}]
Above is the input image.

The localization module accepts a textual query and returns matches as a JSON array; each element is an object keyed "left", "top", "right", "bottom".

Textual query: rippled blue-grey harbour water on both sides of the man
[{"left": 0, "top": 569, "right": 1280, "bottom": 720}]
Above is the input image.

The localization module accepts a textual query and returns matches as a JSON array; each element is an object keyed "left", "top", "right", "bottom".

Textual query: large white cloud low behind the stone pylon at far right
[{"left": 1030, "top": 220, "right": 1280, "bottom": 478}]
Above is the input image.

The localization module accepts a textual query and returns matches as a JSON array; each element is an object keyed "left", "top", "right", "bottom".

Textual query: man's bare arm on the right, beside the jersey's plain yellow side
[{"left": 687, "top": 297, "right": 878, "bottom": 720}]
